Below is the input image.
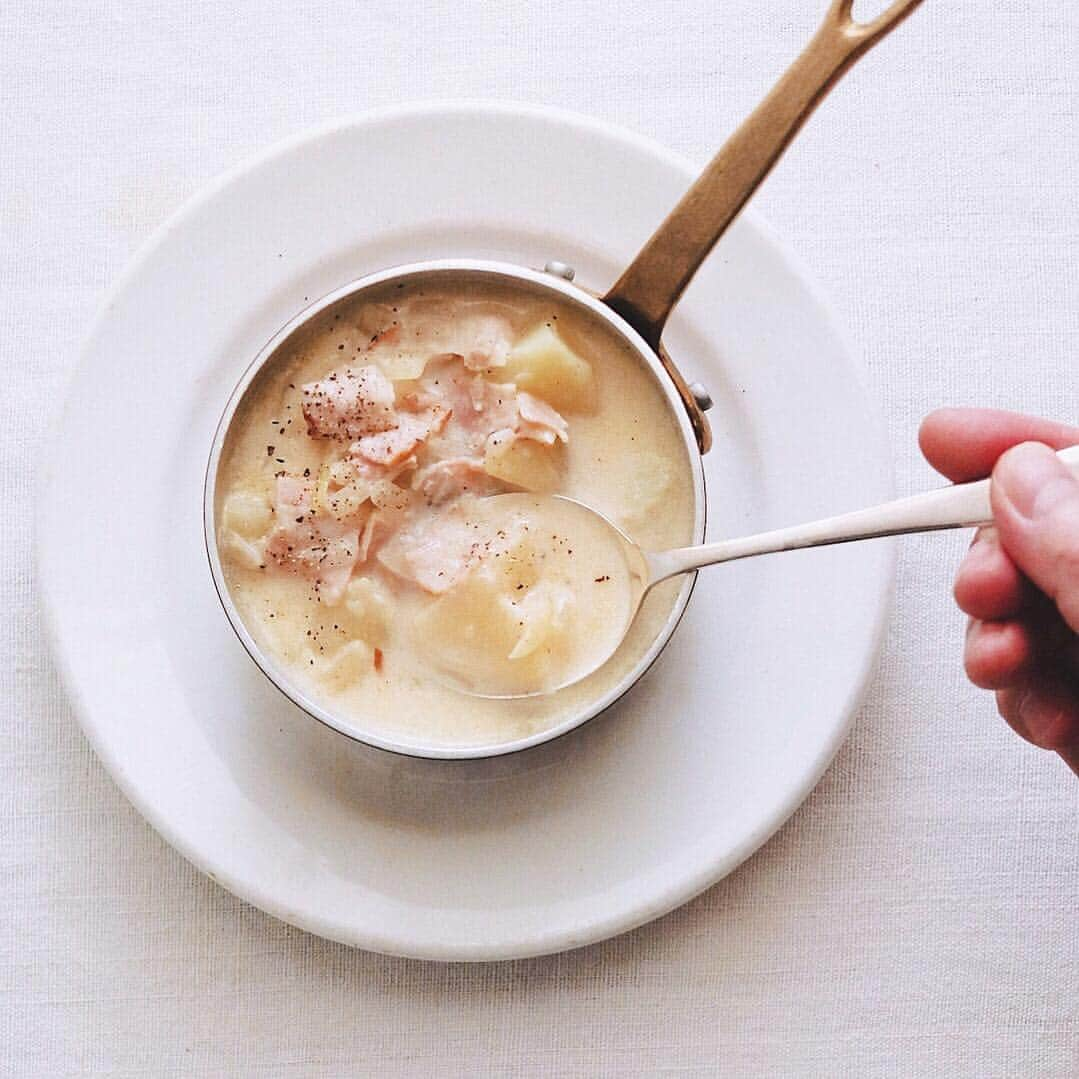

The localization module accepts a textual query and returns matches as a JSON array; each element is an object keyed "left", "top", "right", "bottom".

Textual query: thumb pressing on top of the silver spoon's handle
[{"left": 991, "top": 442, "right": 1079, "bottom": 632}]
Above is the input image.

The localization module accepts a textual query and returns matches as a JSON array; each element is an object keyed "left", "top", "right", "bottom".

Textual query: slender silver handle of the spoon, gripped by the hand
[{"left": 647, "top": 446, "right": 1079, "bottom": 584}]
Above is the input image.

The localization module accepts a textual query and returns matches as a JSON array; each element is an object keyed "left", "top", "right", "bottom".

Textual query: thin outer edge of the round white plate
[{"left": 32, "top": 98, "right": 898, "bottom": 962}]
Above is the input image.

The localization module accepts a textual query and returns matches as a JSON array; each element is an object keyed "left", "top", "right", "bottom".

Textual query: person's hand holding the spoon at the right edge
[{"left": 918, "top": 408, "right": 1079, "bottom": 775}]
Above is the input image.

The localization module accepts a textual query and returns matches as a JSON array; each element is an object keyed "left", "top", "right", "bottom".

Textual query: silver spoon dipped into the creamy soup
[{"left": 453, "top": 446, "right": 1079, "bottom": 699}]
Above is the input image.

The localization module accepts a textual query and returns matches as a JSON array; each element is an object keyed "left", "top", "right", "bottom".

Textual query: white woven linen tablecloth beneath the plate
[{"left": 0, "top": 0, "right": 1079, "bottom": 1079}]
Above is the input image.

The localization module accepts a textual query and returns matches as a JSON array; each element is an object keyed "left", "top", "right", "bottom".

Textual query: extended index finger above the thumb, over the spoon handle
[{"left": 918, "top": 408, "right": 1079, "bottom": 483}]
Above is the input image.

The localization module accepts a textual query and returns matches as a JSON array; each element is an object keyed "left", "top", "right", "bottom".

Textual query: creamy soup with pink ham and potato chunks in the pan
[{"left": 215, "top": 282, "right": 694, "bottom": 746}]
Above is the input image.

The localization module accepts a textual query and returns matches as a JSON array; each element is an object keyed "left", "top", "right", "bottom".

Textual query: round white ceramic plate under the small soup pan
[{"left": 39, "top": 105, "right": 892, "bottom": 959}]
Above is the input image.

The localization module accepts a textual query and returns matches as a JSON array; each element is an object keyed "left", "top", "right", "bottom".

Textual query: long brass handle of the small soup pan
[{"left": 603, "top": 0, "right": 921, "bottom": 347}]
